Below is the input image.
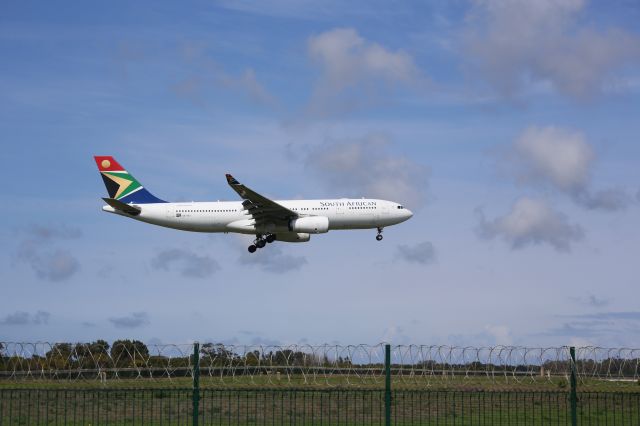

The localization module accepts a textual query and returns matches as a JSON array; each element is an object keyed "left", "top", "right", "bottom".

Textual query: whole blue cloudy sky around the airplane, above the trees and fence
[{"left": 0, "top": 0, "right": 640, "bottom": 347}]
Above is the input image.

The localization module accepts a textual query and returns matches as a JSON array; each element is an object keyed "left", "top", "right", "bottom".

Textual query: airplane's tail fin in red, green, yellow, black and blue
[{"left": 93, "top": 155, "right": 166, "bottom": 207}]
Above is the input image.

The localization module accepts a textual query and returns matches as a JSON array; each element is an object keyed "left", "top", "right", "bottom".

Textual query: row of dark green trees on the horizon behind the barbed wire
[{"left": 0, "top": 339, "right": 640, "bottom": 377}]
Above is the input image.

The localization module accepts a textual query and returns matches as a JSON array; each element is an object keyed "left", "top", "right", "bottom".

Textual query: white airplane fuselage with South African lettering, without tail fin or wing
[{"left": 102, "top": 198, "right": 412, "bottom": 234}]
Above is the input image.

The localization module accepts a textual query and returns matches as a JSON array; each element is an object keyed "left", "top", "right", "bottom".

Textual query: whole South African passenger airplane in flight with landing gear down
[{"left": 94, "top": 155, "right": 413, "bottom": 253}]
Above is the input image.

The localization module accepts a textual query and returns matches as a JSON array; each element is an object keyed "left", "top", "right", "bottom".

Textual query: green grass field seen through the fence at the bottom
[{"left": 0, "top": 375, "right": 640, "bottom": 426}]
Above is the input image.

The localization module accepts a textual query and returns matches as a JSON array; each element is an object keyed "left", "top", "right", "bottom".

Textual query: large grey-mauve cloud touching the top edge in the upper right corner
[{"left": 466, "top": 0, "right": 640, "bottom": 99}]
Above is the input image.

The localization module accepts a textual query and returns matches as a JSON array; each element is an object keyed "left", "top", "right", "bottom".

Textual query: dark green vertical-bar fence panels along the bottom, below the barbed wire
[{"left": 0, "top": 389, "right": 640, "bottom": 426}]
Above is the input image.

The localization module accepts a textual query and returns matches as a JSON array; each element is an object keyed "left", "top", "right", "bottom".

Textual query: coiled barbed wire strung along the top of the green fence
[{"left": 0, "top": 340, "right": 640, "bottom": 387}]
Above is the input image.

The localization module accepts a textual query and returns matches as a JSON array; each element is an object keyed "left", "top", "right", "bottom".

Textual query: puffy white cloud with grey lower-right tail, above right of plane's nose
[{"left": 507, "top": 126, "right": 630, "bottom": 211}]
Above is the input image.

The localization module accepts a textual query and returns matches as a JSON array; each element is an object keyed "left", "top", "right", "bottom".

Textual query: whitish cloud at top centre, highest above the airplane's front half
[{"left": 307, "top": 28, "right": 420, "bottom": 117}]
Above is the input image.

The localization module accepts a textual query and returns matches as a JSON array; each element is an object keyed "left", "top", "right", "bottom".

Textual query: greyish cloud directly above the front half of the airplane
[{"left": 306, "top": 134, "right": 429, "bottom": 209}]
